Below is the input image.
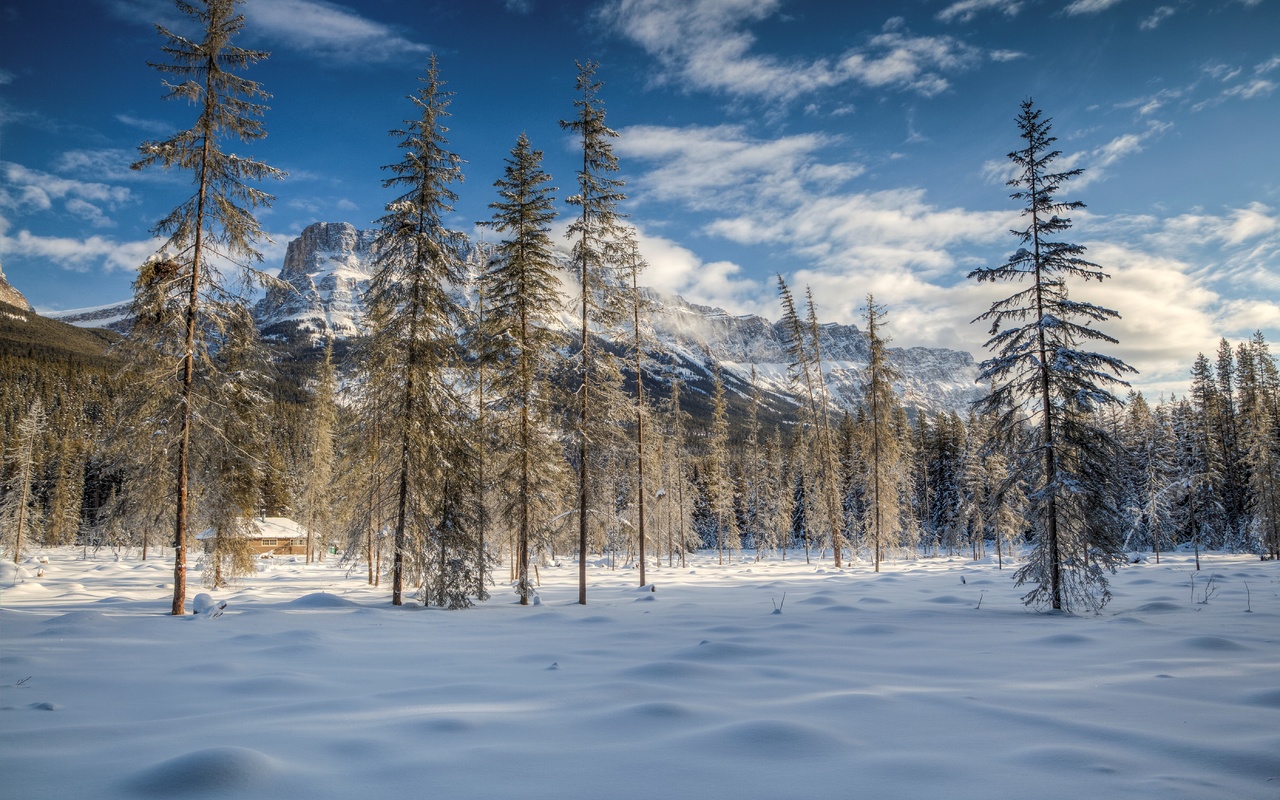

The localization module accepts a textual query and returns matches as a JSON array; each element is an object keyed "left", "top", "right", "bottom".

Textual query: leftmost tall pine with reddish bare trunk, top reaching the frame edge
[{"left": 133, "top": 0, "right": 284, "bottom": 616}]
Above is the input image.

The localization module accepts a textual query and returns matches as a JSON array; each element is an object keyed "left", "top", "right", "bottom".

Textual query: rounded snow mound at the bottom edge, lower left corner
[{"left": 131, "top": 746, "right": 280, "bottom": 797}]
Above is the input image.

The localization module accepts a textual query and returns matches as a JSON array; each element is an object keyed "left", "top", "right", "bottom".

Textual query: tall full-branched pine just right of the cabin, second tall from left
[{"left": 362, "top": 55, "right": 474, "bottom": 607}]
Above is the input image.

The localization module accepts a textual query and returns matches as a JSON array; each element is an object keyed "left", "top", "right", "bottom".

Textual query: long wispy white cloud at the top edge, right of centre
[{"left": 600, "top": 0, "right": 982, "bottom": 100}]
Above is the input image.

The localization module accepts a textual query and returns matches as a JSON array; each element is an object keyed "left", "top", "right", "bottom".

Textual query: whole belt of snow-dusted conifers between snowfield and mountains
[{"left": 0, "top": 0, "right": 1280, "bottom": 614}]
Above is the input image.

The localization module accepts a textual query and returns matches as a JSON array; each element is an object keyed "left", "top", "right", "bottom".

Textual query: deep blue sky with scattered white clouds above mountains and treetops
[{"left": 0, "top": 0, "right": 1280, "bottom": 394}]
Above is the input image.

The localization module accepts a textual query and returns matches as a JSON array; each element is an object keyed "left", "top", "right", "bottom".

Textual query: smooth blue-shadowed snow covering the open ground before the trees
[{"left": 0, "top": 549, "right": 1280, "bottom": 800}]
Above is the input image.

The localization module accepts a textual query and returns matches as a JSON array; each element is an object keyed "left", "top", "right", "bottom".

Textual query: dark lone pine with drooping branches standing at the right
[{"left": 969, "top": 100, "right": 1134, "bottom": 611}]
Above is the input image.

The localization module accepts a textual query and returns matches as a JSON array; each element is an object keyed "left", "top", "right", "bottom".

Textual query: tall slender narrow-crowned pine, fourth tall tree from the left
[{"left": 561, "top": 61, "right": 626, "bottom": 605}]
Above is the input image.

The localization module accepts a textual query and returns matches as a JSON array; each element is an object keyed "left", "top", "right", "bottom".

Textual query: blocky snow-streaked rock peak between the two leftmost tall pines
[{"left": 255, "top": 223, "right": 375, "bottom": 338}]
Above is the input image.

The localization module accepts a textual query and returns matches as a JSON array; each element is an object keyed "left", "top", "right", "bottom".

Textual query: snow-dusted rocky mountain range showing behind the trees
[{"left": 40, "top": 223, "right": 980, "bottom": 419}]
